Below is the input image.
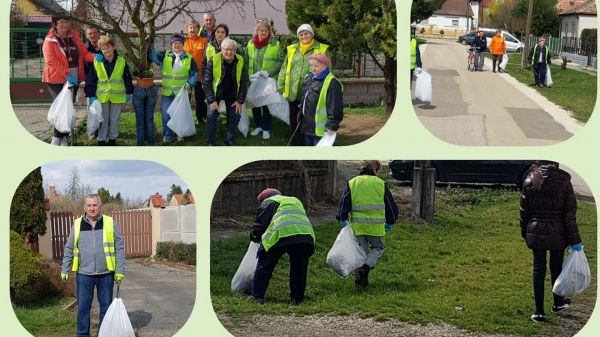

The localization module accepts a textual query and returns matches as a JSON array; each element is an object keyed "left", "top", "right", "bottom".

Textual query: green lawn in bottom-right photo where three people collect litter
[{"left": 210, "top": 188, "right": 596, "bottom": 336}]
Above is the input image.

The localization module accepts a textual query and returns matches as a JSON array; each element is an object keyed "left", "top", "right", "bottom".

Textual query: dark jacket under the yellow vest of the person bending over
[{"left": 250, "top": 199, "right": 314, "bottom": 251}]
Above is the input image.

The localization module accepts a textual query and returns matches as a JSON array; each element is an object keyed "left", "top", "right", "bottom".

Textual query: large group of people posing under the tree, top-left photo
[{"left": 42, "top": 13, "right": 343, "bottom": 146}]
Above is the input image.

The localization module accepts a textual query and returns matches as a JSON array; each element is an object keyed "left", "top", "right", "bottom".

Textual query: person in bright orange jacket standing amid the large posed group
[{"left": 183, "top": 20, "right": 208, "bottom": 124}]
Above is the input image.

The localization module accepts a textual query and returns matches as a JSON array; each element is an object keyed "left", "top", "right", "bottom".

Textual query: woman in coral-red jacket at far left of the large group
[{"left": 42, "top": 16, "right": 96, "bottom": 145}]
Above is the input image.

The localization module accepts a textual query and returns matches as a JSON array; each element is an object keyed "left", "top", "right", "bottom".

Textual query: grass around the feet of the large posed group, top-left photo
[{"left": 75, "top": 106, "right": 386, "bottom": 146}]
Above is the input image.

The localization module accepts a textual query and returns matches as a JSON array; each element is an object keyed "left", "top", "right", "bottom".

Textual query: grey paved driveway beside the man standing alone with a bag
[{"left": 93, "top": 259, "right": 196, "bottom": 337}]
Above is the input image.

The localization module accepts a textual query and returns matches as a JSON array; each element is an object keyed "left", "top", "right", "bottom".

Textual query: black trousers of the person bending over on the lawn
[{"left": 252, "top": 244, "right": 315, "bottom": 302}]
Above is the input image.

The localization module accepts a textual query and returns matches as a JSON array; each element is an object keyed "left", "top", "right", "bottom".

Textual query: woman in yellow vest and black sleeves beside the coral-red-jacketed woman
[{"left": 83, "top": 35, "right": 133, "bottom": 146}]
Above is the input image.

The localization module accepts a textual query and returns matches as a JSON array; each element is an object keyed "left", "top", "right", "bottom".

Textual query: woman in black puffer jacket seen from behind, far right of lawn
[{"left": 521, "top": 162, "right": 583, "bottom": 322}]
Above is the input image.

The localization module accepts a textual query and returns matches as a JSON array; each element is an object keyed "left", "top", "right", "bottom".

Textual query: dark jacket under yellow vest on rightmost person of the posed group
[{"left": 300, "top": 69, "right": 344, "bottom": 136}]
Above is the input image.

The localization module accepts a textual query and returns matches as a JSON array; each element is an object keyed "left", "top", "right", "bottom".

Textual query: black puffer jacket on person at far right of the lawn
[{"left": 521, "top": 165, "right": 581, "bottom": 250}]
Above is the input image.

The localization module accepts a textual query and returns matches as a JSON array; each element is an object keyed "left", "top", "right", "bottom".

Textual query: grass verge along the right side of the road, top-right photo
[{"left": 506, "top": 54, "right": 597, "bottom": 122}]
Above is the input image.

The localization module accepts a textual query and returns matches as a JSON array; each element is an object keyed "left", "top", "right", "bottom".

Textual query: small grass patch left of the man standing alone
[{"left": 14, "top": 298, "right": 77, "bottom": 337}]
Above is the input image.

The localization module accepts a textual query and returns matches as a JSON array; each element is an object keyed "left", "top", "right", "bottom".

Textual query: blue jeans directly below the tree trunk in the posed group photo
[{"left": 133, "top": 86, "right": 158, "bottom": 145}]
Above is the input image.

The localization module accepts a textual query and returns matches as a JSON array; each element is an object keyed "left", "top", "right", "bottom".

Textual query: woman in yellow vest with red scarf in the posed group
[{"left": 244, "top": 20, "right": 284, "bottom": 140}]
